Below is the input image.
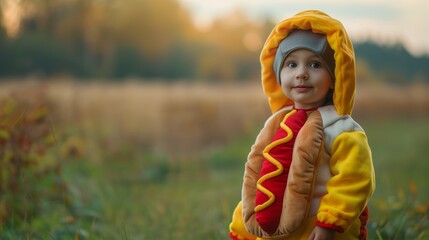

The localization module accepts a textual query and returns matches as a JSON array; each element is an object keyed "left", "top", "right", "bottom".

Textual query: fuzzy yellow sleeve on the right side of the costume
[{"left": 317, "top": 131, "right": 375, "bottom": 231}]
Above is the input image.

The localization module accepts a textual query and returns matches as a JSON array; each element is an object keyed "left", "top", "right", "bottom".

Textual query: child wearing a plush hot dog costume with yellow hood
[{"left": 230, "top": 11, "right": 375, "bottom": 240}]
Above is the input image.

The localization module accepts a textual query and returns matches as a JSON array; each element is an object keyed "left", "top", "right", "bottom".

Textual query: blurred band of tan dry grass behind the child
[{"left": 0, "top": 81, "right": 429, "bottom": 157}]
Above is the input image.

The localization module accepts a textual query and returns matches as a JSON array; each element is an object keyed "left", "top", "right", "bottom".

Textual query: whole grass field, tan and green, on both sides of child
[{"left": 0, "top": 80, "right": 429, "bottom": 240}]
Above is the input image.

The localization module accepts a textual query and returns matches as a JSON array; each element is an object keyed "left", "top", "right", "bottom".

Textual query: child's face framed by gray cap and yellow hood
[{"left": 280, "top": 49, "right": 334, "bottom": 109}]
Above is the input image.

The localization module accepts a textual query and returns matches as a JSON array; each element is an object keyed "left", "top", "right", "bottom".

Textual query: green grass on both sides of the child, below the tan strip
[{"left": 0, "top": 119, "right": 429, "bottom": 240}]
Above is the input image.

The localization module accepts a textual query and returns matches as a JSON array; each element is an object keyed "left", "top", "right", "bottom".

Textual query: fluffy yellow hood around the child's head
[{"left": 260, "top": 10, "right": 356, "bottom": 115}]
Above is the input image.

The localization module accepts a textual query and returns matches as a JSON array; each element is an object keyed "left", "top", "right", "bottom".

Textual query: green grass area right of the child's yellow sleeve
[{"left": 362, "top": 118, "right": 429, "bottom": 239}]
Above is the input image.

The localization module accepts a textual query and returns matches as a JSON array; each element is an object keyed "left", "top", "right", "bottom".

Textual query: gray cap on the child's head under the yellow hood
[{"left": 273, "top": 30, "right": 335, "bottom": 82}]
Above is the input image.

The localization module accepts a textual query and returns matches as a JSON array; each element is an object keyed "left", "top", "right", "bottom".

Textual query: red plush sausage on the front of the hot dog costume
[{"left": 255, "top": 110, "right": 307, "bottom": 234}]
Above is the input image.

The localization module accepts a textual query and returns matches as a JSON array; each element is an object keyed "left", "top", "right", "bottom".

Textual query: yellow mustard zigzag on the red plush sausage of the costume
[{"left": 254, "top": 109, "right": 296, "bottom": 212}]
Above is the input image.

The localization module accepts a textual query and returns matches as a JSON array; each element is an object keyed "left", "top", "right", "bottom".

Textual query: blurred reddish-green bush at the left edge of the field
[{"left": 0, "top": 94, "right": 103, "bottom": 239}]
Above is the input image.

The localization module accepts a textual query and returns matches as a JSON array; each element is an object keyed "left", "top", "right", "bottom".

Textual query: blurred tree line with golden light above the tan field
[{"left": 0, "top": 0, "right": 429, "bottom": 82}]
